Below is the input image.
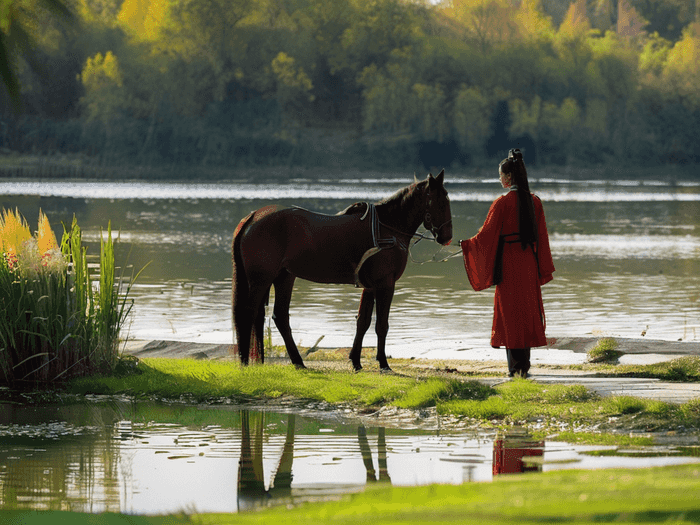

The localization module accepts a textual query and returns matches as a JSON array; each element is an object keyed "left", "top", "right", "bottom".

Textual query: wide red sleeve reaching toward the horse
[{"left": 460, "top": 197, "right": 503, "bottom": 292}]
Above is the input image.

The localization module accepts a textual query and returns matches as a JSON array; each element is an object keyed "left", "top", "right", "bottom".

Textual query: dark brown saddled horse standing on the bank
[{"left": 232, "top": 170, "right": 452, "bottom": 370}]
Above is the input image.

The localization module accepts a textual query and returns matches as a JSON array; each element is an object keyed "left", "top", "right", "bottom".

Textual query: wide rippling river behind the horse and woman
[{"left": 0, "top": 174, "right": 700, "bottom": 363}]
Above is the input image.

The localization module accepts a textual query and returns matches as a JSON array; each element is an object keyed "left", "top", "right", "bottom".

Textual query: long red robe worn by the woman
[{"left": 461, "top": 191, "right": 554, "bottom": 349}]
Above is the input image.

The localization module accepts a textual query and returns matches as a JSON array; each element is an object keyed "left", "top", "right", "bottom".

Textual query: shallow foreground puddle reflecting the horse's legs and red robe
[{"left": 0, "top": 400, "right": 700, "bottom": 514}]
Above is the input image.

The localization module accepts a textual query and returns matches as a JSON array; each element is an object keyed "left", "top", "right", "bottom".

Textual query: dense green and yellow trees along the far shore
[{"left": 0, "top": 0, "right": 700, "bottom": 178}]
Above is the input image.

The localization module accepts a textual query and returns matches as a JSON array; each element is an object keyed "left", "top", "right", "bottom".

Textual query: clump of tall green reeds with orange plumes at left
[{"left": 0, "top": 210, "right": 138, "bottom": 387}]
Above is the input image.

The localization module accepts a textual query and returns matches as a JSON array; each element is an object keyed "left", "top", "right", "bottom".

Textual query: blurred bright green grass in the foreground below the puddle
[{"left": 0, "top": 465, "right": 700, "bottom": 525}]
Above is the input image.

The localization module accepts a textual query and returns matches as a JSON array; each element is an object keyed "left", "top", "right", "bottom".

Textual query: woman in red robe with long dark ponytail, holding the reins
[{"left": 460, "top": 149, "right": 554, "bottom": 377}]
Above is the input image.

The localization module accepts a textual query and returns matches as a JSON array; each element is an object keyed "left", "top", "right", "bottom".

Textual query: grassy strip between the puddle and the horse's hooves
[{"left": 68, "top": 359, "right": 700, "bottom": 444}]
